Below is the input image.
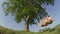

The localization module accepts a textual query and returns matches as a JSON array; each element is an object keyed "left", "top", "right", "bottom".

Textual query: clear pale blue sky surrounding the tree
[{"left": 0, "top": 0, "right": 60, "bottom": 32}]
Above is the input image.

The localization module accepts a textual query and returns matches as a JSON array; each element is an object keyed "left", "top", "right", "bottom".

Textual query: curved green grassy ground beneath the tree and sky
[{"left": 0, "top": 25, "right": 60, "bottom": 34}]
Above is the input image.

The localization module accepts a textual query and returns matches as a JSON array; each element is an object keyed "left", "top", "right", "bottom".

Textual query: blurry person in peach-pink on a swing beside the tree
[{"left": 38, "top": 16, "right": 53, "bottom": 27}]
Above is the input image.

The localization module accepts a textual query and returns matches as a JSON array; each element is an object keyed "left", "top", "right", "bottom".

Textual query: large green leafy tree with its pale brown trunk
[{"left": 3, "top": 0, "right": 54, "bottom": 31}]
